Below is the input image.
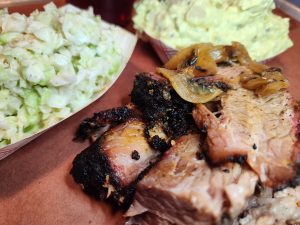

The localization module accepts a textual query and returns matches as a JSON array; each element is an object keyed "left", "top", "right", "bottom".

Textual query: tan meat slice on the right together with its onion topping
[{"left": 157, "top": 43, "right": 300, "bottom": 187}]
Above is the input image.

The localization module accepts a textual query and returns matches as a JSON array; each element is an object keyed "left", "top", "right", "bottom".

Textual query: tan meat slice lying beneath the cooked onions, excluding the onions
[{"left": 193, "top": 64, "right": 300, "bottom": 186}]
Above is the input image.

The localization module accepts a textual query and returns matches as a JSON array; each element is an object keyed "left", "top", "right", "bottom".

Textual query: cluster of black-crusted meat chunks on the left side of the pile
[{"left": 71, "top": 73, "right": 196, "bottom": 209}]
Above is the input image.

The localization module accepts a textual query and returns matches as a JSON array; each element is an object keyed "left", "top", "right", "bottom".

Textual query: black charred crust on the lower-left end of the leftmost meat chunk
[{"left": 70, "top": 138, "right": 152, "bottom": 210}]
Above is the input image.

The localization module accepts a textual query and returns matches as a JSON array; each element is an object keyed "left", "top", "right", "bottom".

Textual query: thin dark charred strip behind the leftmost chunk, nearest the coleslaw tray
[{"left": 75, "top": 107, "right": 134, "bottom": 141}]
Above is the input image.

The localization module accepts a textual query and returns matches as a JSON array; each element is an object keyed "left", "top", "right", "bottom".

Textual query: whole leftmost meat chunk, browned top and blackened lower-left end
[{"left": 71, "top": 119, "right": 159, "bottom": 208}]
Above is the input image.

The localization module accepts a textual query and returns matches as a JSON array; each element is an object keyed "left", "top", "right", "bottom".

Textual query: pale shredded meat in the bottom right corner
[{"left": 234, "top": 186, "right": 300, "bottom": 225}]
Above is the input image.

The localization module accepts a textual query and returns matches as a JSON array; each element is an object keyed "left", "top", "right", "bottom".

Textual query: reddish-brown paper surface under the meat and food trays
[{"left": 0, "top": 7, "right": 300, "bottom": 225}]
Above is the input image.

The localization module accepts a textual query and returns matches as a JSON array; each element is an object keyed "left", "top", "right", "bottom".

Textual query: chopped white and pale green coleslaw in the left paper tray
[{"left": 0, "top": 3, "right": 123, "bottom": 147}]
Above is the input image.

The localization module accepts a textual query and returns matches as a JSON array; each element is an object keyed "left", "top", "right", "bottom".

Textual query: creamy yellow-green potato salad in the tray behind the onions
[{"left": 133, "top": 0, "right": 292, "bottom": 61}]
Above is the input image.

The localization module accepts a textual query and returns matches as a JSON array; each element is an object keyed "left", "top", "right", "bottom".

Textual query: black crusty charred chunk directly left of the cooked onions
[{"left": 131, "top": 73, "right": 195, "bottom": 152}]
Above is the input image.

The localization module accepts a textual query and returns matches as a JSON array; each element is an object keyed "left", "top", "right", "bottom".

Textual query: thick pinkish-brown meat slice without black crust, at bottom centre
[{"left": 127, "top": 134, "right": 258, "bottom": 225}]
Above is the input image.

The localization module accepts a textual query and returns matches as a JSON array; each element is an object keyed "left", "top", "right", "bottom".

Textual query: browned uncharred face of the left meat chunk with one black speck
[{"left": 101, "top": 120, "right": 158, "bottom": 186}]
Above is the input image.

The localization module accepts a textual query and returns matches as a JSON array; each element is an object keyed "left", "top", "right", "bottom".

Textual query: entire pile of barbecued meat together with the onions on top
[{"left": 71, "top": 43, "right": 300, "bottom": 225}]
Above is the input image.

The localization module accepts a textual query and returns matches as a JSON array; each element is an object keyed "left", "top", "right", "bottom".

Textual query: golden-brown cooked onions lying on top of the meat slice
[{"left": 163, "top": 42, "right": 288, "bottom": 99}]
